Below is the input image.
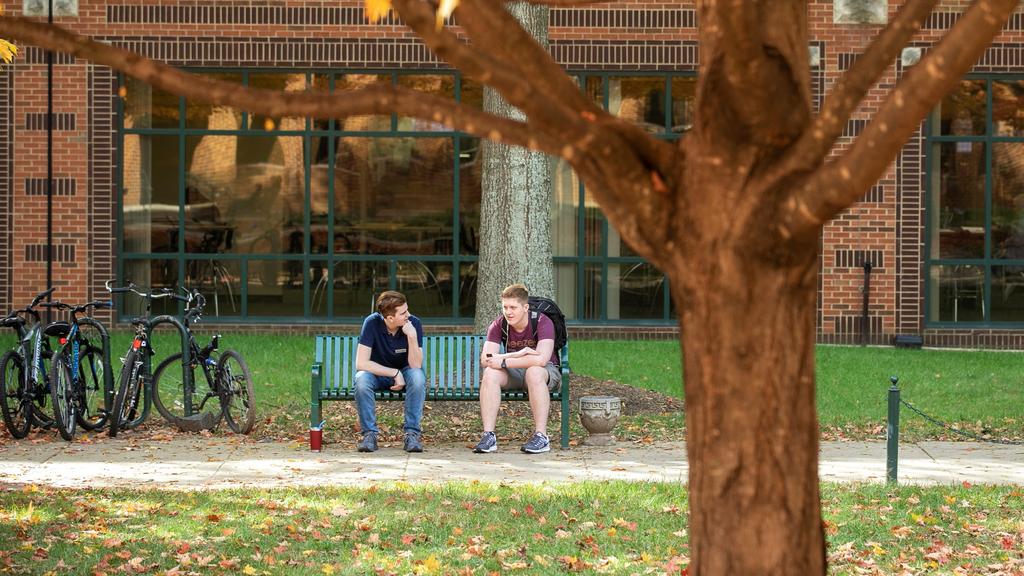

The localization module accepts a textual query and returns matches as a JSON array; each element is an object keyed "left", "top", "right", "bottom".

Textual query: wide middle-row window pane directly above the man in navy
[{"left": 334, "top": 137, "right": 455, "bottom": 255}]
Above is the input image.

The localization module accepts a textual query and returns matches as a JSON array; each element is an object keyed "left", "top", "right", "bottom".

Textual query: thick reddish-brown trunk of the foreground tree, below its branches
[{"left": 670, "top": 219, "right": 825, "bottom": 576}]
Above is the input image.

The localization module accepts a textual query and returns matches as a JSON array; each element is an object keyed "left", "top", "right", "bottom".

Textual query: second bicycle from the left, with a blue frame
[{"left": 40, "top": 300, "right": 114, "bottom": 441}]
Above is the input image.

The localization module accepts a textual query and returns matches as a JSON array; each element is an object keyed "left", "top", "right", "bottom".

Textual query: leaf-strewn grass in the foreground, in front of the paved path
[{"left": 0, "top": 482, "right": 1024, "bottom": 575}]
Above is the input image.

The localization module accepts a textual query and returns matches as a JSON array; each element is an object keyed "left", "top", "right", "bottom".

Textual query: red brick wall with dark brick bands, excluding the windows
[{"left": 0, "top": 0, "right": 1024, "bottom": 347}]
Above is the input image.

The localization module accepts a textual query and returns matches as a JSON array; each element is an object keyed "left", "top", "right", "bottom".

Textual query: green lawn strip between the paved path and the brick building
[{"left": 0, "top": 332, "right": 1024, "bottom": 439}]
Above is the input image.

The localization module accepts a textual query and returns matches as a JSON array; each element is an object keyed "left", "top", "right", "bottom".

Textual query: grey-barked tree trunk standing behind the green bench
[{"left": 474, "top": 2, "right": 555, "bottom": 334}]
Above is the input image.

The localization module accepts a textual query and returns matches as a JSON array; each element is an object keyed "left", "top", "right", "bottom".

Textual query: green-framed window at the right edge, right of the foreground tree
[{"left": 926, "top": 76, "right": 1024, "bottom": 325}]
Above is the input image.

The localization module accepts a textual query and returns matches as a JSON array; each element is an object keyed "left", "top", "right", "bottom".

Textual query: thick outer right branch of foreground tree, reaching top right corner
[{"left": 777, "top": 0, "right": 1018, "bottom": 240}]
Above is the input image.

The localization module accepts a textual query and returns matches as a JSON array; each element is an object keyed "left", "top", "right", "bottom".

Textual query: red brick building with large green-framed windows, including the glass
[{"left": 0, "top": 0, "right": 1024, "bottom": 347}]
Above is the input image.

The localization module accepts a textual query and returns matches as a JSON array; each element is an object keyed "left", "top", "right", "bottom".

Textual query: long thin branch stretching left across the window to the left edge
[{"left": 0, "top": 16, "right": 564, "bottom": 155}]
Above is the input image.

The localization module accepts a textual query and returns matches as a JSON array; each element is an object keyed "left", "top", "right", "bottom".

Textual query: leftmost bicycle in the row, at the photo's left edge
[{"left": 0, "top": 288, "right": 55, "bottom": 439}]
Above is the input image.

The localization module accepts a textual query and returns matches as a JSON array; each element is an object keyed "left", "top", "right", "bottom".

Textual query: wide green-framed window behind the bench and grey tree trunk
[{"left": 119, "top": 71, "right": 696, "bottom": 323}]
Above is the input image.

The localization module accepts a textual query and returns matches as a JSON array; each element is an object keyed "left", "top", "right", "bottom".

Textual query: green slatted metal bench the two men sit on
[{"left": 309, "top": 335, "right": 569, "bottom": 449}]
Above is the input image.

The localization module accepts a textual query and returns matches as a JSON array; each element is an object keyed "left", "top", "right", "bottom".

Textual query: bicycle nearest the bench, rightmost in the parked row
[{"left": 153, "top": 290, "right": 256, "bottom": 434}]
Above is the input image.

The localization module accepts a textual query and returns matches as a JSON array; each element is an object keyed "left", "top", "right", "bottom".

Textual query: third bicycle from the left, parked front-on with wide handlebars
[{"left": 106, "top": 281, "right": 190, "bottom": 438}]
